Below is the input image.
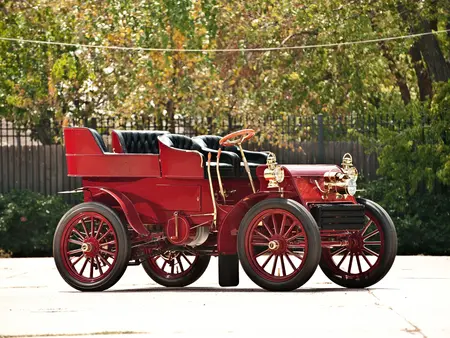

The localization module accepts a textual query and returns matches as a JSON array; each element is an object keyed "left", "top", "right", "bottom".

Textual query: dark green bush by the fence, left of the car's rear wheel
[{"left": 0, "top": 191, "right": 71, "bottom": 257}]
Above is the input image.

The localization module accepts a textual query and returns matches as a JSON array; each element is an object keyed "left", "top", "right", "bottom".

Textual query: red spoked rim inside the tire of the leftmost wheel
[{"left": 61, "top": 212, "right": 118, "bottom": 283}]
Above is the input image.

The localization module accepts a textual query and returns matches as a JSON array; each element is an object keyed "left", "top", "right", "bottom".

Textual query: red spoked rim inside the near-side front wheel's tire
[{"left": 245, "top": 209, "right": 308, "bottom": 282}]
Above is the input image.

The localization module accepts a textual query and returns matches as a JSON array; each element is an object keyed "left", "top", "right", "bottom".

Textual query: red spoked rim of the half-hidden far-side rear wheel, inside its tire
[{"left": 148, "top": 251, "right": 198, "bottom": 279}]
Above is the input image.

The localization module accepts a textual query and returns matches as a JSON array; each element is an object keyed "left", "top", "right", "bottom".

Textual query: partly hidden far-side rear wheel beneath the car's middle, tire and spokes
[{"left": 142, "top": 251, "right": 211, "bottom": 287}]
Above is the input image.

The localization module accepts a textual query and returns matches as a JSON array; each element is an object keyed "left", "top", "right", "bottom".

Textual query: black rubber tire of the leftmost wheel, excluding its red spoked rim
[{"left": 53, "top": 202, "right": 131, "bottom": 291}]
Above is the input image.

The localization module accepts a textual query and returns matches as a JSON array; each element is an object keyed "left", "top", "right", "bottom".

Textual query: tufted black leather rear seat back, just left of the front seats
[{"left": 114, "top": 130, "right": 168, "bottom": 154}]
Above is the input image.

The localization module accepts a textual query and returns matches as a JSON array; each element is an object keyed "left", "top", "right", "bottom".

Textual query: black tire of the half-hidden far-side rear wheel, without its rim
[{"left": 142, "top": 252, "right": 211, "bottom": 287}]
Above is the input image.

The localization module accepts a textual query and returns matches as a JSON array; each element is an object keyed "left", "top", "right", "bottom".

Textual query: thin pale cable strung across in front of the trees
[{"left": 0, "top": 29, "right": 450, "bottom": 53}]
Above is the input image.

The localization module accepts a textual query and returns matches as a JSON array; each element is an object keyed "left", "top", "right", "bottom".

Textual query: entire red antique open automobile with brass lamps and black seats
[{"left": 53, "top": 127, "right": 397, "bottom": 291}]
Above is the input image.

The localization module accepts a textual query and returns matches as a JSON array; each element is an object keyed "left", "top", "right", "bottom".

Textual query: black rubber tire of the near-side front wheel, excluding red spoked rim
[{"left": 237, "top": 198, "right": 321, "bottom": 291}]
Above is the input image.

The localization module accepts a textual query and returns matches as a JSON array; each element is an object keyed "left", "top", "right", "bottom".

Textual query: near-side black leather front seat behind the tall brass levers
[{"left": 158, "top": 134, "right": 237, "bottom": 178}]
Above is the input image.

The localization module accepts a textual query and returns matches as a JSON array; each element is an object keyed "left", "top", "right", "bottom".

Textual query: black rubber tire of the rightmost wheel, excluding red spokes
[{"left": 319, "top": 198, "right": 398, "bottom": 289}]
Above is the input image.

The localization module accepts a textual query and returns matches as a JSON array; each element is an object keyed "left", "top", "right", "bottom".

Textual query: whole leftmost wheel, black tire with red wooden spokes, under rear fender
[{"left": 53, "top": 202, "right": 131, "bottom": 291}]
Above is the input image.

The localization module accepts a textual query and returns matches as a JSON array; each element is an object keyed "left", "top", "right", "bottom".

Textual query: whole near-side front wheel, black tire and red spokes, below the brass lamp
[{"left": 238, "top": 198, "right": 321, "bottom": 291}]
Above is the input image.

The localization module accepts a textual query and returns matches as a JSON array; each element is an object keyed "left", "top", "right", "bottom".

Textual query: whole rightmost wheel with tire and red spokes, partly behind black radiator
[{"left": 320, "top": 199, "right": 397, "bottom": 288}]
